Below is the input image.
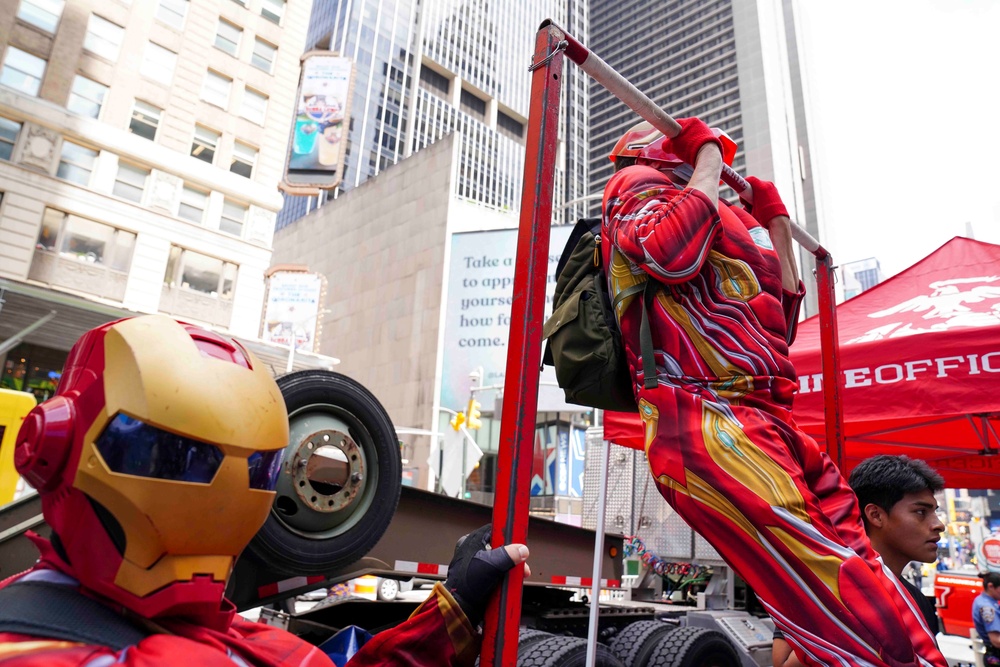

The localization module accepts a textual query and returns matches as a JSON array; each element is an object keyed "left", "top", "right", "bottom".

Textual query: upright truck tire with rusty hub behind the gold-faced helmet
[{"left": 247, "top": 370, "right": 402, "bottom": 576}]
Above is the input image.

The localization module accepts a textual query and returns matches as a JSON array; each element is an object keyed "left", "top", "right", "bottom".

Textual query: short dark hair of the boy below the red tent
[{"left": 847, "top": 454, "right": 944, "bottom": 527}]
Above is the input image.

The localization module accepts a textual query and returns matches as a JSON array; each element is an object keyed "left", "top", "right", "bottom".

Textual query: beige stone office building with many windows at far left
[{"left": 0, "top": 0, "right": 324, "bottom": 398}]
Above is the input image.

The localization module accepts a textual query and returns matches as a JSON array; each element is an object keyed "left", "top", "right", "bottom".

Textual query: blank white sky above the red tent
[{"left": 799, "top": 0, "right": 1000, "bottom": 277}]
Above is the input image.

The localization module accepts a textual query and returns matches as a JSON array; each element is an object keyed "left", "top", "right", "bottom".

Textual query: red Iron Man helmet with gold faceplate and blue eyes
[{"left": 15, "top": 315, "right": 288, "bottom": 618}]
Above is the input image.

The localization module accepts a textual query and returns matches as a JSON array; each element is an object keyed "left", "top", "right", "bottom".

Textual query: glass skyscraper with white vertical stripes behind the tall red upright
[{"left": 278, "top": 0, "right": 589, "bottom": 228}]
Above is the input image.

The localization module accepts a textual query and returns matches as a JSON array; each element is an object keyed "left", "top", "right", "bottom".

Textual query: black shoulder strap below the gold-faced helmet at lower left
[{"left": 0, "top": 581, "right": 151, "bottom": 651}]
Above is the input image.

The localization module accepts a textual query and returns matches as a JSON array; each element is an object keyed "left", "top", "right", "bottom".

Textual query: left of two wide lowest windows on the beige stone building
[{"left": 35, "top": 208, "right": 135, "bottom": 273}]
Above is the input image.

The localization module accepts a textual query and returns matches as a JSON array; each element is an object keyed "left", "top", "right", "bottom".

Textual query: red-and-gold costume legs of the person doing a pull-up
[{"left": 639, "top": 392, "right": 946, "bottom": 667}]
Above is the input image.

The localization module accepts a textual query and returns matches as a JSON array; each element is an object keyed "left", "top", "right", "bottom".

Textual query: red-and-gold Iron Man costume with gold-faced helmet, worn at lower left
[{"left": 0, "top": 315, "right": 478, "bottom": 667}]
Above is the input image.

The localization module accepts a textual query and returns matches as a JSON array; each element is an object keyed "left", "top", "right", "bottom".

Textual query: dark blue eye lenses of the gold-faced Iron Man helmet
[{"left": 95, "top": 413, "right": 284, "bottom": 490}]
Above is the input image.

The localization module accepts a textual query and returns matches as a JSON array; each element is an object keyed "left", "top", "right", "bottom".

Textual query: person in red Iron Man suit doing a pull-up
[{"left": 602, "top": 118, "right": 947, "bottom": 667}]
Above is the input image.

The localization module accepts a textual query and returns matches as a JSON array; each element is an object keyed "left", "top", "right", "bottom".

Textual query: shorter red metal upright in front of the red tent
[{"left": 816, "top": 254, "right": 847, "bottom": 476}]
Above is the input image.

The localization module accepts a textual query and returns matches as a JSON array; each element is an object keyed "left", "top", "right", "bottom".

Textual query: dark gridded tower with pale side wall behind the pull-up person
[{"left": 589, "top": 0, "right": 822, "bottom": 314}]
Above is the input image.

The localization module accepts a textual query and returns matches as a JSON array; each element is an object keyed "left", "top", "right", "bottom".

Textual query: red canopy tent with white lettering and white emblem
[{"left": 604, "top": 237, "right": 1000, "bottom": 488}]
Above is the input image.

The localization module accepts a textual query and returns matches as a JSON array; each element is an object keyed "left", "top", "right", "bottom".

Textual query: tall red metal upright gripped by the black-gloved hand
[{"left": 480, "top": 20, "right": 564, "bottom": 667}]
